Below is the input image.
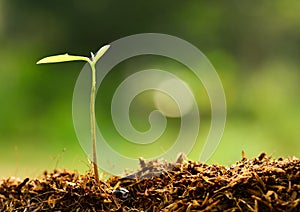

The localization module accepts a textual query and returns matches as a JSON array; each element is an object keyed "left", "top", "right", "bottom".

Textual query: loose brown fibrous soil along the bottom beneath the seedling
[{"left": 0, "top": 153, "right": 300, "bottom": 212}]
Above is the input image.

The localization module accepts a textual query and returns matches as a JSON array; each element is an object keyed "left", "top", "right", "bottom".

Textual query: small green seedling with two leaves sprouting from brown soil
[{"left": 37, "top": 45, "right": 110, "bottom": 182}]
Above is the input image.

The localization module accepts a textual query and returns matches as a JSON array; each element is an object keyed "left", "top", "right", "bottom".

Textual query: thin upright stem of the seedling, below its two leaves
[{"left": 90, "top": 61, "right": 99, "bottom": 182}]
